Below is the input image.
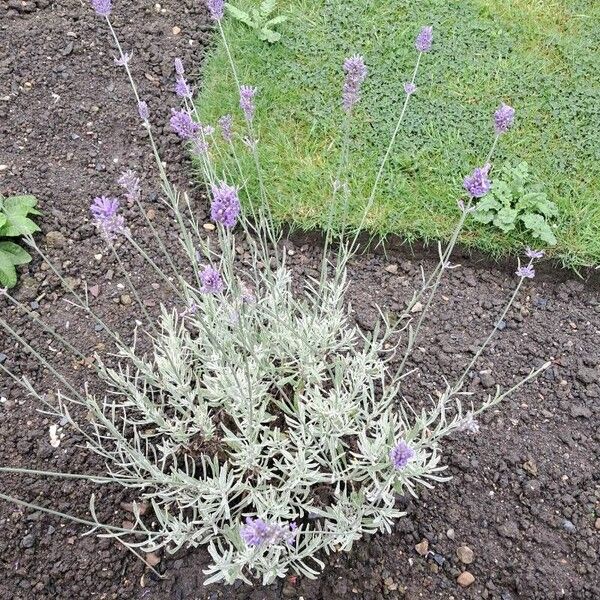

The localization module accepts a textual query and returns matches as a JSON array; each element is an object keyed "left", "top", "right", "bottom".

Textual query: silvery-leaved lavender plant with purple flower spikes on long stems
[{"left": 0, "top": 0, "right": 547, "bottom": 584}]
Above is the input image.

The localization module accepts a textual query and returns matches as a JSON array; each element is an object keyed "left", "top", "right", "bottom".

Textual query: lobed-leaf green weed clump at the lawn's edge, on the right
[{"left": 473, "top": 162, "right": 558, "bottom": 246}]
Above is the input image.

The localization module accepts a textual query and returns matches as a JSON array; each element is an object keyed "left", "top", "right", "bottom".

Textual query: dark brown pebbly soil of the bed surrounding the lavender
[{"left": 0, "top": 0, "right": 600, "bottom": 600}]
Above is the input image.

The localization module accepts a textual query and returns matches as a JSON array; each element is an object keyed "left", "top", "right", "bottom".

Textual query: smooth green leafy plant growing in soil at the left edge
[{"left": 0, "top": 196, "right": 40, "bottom": 288}]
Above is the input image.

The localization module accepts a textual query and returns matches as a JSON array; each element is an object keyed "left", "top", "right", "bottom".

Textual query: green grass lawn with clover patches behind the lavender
[{"left": 198, "top": 0, "right": 600, "bottom": 266}]
